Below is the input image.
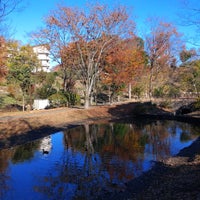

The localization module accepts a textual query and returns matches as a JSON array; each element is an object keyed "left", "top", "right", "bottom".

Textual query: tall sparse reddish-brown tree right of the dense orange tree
[{"left": 145, "top": 21, "right": 181, "bottom": 98}]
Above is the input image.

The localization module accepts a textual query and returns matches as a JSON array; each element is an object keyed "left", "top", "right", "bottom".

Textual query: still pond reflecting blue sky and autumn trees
[{"left": 0, "top": 121, "right": 199, "bottom": 200}]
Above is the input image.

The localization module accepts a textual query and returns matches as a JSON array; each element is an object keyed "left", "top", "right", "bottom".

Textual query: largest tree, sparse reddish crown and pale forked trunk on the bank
[{"left": 32, "top": 4, "right": 134, "bottom": 108}]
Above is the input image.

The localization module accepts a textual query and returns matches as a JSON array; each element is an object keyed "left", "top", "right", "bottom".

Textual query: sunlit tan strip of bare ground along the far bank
[{"left": 0, "top": 106, "right": 115, "bottom": 137}]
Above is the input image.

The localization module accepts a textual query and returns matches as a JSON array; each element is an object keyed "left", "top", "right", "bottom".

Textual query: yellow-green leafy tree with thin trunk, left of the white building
[{"left": 7, "top": 43, "right": 39, "bottom": 111}]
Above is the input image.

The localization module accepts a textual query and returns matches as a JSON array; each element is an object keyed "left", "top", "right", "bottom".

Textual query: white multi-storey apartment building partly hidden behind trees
[{"left": 33, "top": 45, "right": 50, "bottom": 72}]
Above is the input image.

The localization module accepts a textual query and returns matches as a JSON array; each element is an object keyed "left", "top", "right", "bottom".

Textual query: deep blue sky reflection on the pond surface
[{"left": 0, "top": 121, "right": 198, "bottom": 200}]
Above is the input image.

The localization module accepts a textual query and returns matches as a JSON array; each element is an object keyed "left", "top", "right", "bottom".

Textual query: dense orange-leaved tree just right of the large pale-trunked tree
[{"left": 102, "top": 36, "right": 145, "bottom": 99}]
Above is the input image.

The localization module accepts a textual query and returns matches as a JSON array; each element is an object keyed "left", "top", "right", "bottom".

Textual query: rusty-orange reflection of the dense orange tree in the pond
[{"left": 100, "top": 124, "right": 147, "bottom": 181}]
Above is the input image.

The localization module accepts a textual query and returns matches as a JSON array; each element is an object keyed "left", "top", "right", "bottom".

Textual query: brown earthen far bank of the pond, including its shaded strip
[{"left": 0, "top": 103, "right": 139, "bottom": 148}]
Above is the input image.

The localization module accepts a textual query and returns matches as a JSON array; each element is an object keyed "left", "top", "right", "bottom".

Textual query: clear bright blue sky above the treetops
[{"left": 7, "top": 0, "right": 195, "bottom": 43}]
